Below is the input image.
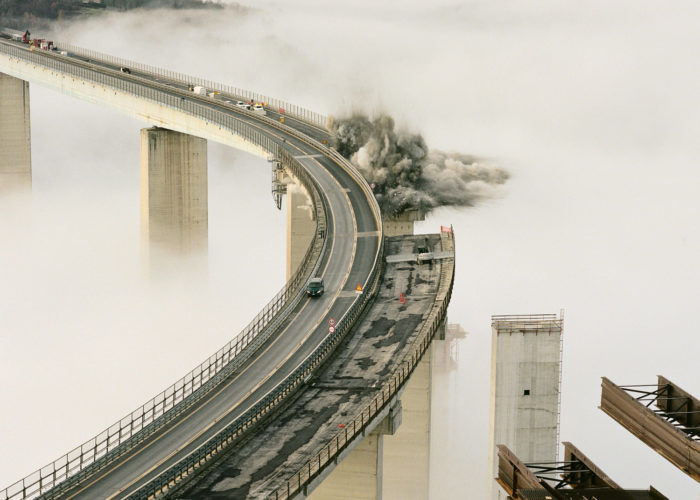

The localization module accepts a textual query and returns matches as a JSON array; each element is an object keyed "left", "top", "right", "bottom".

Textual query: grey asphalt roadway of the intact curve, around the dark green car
[{"left": 0, "top": 38, "right": 378, "bottom": 498}]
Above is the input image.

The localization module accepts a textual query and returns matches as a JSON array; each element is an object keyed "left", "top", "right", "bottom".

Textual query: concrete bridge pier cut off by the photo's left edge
[{"left": 0, "top": 73, "right": 32, "bottom": 190}]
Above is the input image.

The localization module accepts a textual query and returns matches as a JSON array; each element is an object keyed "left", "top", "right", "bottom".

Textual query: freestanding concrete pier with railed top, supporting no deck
[{"left": 489, "top": 314, "right": 563, "bottom": 499}]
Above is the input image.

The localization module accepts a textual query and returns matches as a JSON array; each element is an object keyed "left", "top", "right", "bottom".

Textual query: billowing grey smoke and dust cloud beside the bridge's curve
[{"left": 329, "top": 114, "right": 509, "bottom": 216}]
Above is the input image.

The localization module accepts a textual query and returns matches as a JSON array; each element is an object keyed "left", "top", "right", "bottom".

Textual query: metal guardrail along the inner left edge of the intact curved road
[{"left": 0, "top": 43, "right": 326, "bottom": 500}]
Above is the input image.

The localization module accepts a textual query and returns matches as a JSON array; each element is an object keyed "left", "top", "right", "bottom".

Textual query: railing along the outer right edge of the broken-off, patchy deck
[{"left": 268, "top": 228, "right": 455, "bottom": 500}]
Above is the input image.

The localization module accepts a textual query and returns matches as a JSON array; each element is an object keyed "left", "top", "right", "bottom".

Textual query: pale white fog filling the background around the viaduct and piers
[{"left": 0, "top": 0, "right": 700, "bottom": 500}]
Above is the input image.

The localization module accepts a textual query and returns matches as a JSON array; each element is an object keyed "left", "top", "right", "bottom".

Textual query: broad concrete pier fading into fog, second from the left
[{"left": 141, "top": 127, "right": 208, "bottom": 257}]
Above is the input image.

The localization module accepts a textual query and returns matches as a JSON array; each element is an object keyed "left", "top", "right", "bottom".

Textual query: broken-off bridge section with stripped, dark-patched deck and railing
[{"left": 178, "top": 232, "right": 455, "bottom": 499}]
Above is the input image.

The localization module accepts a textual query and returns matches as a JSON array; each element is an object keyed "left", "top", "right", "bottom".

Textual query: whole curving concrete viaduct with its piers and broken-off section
[{"left": 0, "top": 39, "right": 454, "bottom": 500}]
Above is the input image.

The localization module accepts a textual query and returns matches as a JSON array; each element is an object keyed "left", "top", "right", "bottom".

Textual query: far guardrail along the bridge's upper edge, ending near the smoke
[{"left": 56, "top": 42, "right": 327, "bottom": 130}]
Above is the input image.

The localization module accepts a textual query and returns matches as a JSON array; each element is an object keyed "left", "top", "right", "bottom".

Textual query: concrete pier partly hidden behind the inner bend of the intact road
[{"left": 287, "top": 184, "right": 316, "bottom": 279}]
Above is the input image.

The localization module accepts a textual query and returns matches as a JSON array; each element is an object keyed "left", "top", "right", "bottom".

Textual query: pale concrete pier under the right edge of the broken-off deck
[{"left": 382, "top": 345, "right": 433, "bottom": 500}]
